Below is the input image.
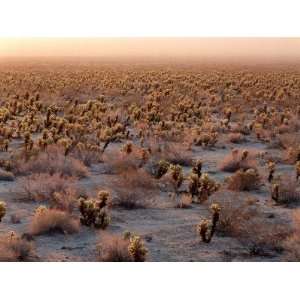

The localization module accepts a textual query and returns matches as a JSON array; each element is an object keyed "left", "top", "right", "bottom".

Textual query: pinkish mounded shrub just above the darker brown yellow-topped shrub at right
[{"left": 219, "top": 149, "right": 257, "bottom": 172}]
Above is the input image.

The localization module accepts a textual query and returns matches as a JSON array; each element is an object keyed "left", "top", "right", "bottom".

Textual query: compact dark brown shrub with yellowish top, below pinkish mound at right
[{"left": 227, "top": 169, "right": 260, "bottom": 191}]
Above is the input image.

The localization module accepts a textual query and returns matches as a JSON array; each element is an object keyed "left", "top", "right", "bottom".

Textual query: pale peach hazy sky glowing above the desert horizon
[{"left": 0, "top": 38, "right": 300, "bottom": 59}]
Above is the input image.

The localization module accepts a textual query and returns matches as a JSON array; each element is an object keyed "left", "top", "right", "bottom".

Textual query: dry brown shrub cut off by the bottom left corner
[{"left": 0, "top": 232, "right": 36, "bottom": 261}]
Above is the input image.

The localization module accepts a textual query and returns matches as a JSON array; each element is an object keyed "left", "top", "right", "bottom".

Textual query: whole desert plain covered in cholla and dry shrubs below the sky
[{"left": 0, "top": 59, "right": 300, "bottom": 262}]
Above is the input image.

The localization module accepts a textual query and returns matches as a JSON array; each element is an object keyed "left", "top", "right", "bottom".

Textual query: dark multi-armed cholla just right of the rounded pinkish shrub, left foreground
[{"left": 79, "top": 191, "right": 110, "bottom": 229}]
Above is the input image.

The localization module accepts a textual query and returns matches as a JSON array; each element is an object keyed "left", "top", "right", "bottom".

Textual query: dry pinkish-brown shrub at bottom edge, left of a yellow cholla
[{"left": 97, "top": 235, "right": 132, "bottom": 262}]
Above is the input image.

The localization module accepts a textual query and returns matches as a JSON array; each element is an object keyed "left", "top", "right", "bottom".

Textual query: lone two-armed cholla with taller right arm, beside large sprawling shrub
[{"left": 197, "top": 204, "right": 221, "bottom": 243}]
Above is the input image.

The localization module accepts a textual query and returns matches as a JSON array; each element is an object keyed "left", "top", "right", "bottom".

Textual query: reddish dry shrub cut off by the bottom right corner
[{"left": 283, "top": 209, "right": 300, "bottom": 262}]
